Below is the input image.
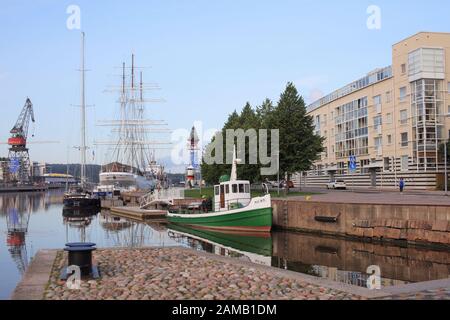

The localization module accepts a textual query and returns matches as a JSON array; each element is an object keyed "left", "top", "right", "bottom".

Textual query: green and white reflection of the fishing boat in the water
[{"left": 167, "top": 224, "right": 272, "bottom": 266}]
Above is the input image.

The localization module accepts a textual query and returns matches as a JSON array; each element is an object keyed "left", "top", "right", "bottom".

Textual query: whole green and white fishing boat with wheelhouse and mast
[{"left": 167, "top": 146, "right": 272, "bottom": 232}]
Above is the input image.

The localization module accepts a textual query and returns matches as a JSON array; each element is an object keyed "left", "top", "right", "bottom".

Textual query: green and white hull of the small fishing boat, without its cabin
[{"left": 167, "top": 195, "right": 272, "bottom": 232}]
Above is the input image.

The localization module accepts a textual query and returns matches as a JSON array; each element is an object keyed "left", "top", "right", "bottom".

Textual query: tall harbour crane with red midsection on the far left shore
[{"left": 8, "top": 98, "right": 35, "bottom": 184}]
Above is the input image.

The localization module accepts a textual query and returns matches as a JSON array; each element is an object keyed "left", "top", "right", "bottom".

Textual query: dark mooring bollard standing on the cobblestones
[{"left": 64, "top": 242, "right": 97, "bottom": 276}]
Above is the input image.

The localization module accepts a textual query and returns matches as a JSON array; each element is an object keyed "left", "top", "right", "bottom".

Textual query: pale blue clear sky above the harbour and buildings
[{"left": 0, "top": 0, "right": 450, "bottom": 172}]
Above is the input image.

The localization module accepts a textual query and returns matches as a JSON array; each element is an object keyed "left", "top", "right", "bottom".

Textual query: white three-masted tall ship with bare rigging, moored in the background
[{"left": 96, "top": 54, "right": 170, "bottom": 191}]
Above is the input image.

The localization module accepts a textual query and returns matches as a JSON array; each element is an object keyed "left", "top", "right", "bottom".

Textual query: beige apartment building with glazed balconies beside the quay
[{"left": 297, "top": 32, "right": 450, "bottom": 189}]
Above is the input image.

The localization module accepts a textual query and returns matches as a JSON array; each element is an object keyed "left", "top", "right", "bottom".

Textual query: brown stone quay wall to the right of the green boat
[{"left": 272, "top": 199, "right": 450, "bottom": 248}]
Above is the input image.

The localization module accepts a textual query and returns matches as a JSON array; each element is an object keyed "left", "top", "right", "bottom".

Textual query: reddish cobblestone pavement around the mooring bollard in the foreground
[{"left": 44, "top": 248, "right": 363, "bottom": 300}]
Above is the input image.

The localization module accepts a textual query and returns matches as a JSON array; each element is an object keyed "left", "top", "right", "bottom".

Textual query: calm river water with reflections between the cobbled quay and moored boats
[{"left": 0, "top": 191, "right": 450, "bottom": 299}]
